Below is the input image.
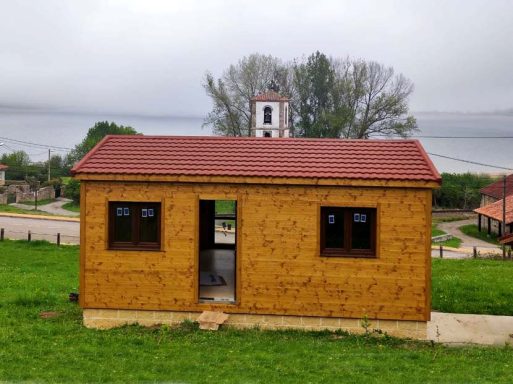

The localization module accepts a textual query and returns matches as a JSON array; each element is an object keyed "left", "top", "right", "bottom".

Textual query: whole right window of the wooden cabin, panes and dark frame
[{"left": 320, "top": 207, "right": 376, "bottom": 257}]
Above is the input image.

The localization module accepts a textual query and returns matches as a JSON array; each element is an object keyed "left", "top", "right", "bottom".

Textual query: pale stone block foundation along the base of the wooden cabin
[{"left": 84, "top": 309, "right": 427, "bottom": 340}]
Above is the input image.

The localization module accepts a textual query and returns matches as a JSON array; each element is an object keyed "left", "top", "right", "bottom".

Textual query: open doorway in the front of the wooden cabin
[{"left": 198, "top": 200, "right": 237, "bottom": 303}]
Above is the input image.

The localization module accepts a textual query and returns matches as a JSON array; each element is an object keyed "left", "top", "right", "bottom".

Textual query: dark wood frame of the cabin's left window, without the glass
[{"left": 108, "top": 201, "right": 161, "bottom": 251}]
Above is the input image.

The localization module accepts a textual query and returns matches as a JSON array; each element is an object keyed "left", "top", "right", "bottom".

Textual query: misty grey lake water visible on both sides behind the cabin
[{"left": 0, "top": 110, "right": 513, "bottom": 173}]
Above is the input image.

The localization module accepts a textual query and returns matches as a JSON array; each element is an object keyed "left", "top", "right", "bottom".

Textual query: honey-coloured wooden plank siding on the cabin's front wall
[{"left": 80, "top": 177, "right": 431, "bottom": 321}]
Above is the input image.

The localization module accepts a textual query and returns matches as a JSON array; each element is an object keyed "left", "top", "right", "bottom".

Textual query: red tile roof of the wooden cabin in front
[{"left": 72, "top": 135, "right": 440, "bottom": 182}]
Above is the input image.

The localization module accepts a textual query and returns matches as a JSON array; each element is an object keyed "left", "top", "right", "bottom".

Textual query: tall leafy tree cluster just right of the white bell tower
[{"left": 293, "top": 52, "right": 417, "bottom": 139}]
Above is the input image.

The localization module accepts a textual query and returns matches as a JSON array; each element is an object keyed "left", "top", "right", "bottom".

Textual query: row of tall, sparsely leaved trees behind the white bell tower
[{"left": 203, "top": 51, "right": 417, "bottom": 139}]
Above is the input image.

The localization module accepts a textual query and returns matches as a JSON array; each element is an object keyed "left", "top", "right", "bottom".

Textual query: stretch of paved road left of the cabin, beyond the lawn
[{"left": 0, "top": 216, "right": 80, "bottom": 244}]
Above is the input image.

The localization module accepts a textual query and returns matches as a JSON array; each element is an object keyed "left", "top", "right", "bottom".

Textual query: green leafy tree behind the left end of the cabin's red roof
[{"left": 65, "top": 121, "right": 139, "bottom": 168}]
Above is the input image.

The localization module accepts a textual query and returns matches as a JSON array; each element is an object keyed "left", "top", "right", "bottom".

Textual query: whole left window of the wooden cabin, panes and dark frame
[{"left": 109, "top": 202, "right": 160, "bottom": 249}]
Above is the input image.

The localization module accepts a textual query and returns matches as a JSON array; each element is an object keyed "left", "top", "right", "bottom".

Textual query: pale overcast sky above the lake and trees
[{"left": 0, "top": 0, "right": 513, "bottom": 116}]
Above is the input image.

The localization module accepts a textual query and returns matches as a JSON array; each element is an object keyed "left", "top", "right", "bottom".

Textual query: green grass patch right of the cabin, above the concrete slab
[{"left": 432, "top": 259, "right": 513, "bottom": 316}]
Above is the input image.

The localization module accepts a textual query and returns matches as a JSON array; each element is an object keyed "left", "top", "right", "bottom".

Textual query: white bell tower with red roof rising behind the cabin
[{"left": 251, "top": 91, "right": 290, "bottom": 137}]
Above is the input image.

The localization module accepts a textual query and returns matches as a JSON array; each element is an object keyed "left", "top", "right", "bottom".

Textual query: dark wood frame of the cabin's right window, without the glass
[{"left": 320, "top": 206, "right": 378, "bottom": 258}]
